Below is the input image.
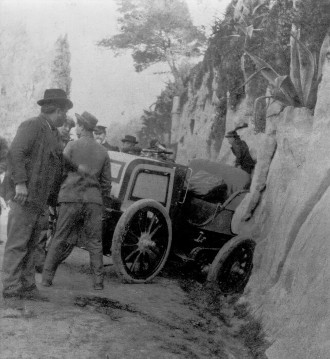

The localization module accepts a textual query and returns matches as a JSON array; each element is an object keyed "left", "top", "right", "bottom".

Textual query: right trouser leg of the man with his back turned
[{"left": 84, "top": 203, "right": 104, "bottom": 284}]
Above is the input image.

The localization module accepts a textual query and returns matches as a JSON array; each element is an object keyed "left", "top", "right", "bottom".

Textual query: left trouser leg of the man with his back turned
[{"left": 42, "top": 203, "right": 82, "bottom": 282}]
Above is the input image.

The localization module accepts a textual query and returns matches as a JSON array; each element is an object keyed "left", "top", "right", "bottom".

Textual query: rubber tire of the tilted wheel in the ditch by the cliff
[{"left": 207, "top": 236, "right": 256, "bottom": 295}]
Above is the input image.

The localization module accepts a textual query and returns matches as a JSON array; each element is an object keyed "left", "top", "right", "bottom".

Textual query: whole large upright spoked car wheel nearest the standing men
[{"left": 111, "top": 199, "right": 172, "bottom": 283}]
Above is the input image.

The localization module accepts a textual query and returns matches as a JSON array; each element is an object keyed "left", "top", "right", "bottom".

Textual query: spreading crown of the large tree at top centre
[{"left": 98, "top": 0, "right": 206, "bottom": 89}]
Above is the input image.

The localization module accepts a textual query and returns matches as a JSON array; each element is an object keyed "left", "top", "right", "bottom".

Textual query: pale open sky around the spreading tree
[{"left": 0, "top": 0, "right": 230, "bottom": 126}]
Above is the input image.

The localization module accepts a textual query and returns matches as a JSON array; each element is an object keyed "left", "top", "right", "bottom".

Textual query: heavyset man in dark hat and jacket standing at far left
[{"left": 2, "top": 89, "right": 73, "bottom": 309}]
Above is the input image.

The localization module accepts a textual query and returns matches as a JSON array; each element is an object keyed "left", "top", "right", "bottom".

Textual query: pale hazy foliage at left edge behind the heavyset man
[{"left": 0, "top": 23, "right": 50, "bottom": 142}]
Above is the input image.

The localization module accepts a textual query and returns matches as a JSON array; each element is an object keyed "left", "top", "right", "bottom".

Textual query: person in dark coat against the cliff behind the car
[{"left": 225, "top": 130, "right": 255, "bottom": 174}]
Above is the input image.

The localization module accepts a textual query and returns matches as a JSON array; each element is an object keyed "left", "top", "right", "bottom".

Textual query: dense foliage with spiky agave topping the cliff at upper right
[{"left": 209, "top": 0, "right": 330, "bottom": 119}]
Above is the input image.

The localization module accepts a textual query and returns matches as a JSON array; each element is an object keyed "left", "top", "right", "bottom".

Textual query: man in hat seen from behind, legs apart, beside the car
[{"left": 41, "top": 112, "right": 111, "bottom": 290}]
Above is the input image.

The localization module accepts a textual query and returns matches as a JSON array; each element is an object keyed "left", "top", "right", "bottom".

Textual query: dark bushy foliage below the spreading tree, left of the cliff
[{"left": 138, "top": 83, "right": 176, "bottom": 147}]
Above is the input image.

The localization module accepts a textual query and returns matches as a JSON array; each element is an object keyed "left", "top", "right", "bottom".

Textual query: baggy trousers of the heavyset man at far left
[{"left": 2, "top": 202, "right": 40, "bottom": 296}]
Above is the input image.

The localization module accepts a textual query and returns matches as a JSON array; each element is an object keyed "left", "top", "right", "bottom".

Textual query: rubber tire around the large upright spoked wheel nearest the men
[{"left": 111, "top": 199, "right": 172, "bottom": 283}]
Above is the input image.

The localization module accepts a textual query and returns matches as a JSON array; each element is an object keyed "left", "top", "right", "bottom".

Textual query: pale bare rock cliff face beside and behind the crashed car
[{"left": 171, "top": 24, "right": 330, "bottom": 359}]
